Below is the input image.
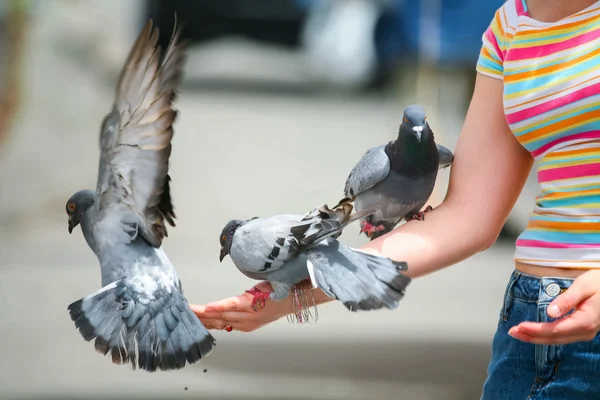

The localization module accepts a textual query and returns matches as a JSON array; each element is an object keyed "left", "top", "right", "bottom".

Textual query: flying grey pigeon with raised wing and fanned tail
[{"left": 66, "top": 21, "right": 216, "bottom": 372}]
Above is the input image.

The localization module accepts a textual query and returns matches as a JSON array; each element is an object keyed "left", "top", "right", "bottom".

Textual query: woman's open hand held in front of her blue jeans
[{"left": 508, "top": 270, "right": 600, "bottom": 344}]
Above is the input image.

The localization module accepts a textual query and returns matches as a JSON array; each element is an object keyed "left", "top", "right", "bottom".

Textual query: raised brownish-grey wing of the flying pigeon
[{"left": 95, "top": 20, "right": 185, "bottom": 247}]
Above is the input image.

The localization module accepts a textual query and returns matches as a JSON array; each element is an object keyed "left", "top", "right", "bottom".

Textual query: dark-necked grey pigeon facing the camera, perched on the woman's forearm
[{"left": 334, "top": 105, "right": 454, "bottom": 240}]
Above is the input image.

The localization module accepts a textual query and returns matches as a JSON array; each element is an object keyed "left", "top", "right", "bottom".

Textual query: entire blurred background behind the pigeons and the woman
[{"left": 0, "top": 0, "right": 537, "bottom": 400}]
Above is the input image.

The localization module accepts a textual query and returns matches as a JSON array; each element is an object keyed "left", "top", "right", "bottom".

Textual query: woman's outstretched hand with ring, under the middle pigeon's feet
[{"left": 190, "top": 281, "right": 292, "bottom": 332}]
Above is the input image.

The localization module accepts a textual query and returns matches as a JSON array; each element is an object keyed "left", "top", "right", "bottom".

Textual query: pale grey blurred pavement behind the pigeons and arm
[{"left": 0, "top": 3, "right": 512, "bottom": 400}]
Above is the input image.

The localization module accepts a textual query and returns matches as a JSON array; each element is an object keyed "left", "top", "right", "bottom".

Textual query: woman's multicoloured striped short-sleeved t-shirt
[{"left": 477, "top": 0, "right": 600, "bottom": 268}]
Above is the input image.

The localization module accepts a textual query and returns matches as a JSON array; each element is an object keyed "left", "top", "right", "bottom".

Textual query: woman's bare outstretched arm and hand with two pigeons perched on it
[{"left": 192, "top": 74, "right": 533, "bottom": 331}]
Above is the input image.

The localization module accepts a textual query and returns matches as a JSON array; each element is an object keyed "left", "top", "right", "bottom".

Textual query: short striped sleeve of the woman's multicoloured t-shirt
[{"left": 476, "top": 8, "right": 506, "bottom": 79}]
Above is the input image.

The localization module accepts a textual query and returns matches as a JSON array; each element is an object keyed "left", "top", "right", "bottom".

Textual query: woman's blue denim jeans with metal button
[{"left": 481, "top": 271, "right": 600, "bottom": 400}]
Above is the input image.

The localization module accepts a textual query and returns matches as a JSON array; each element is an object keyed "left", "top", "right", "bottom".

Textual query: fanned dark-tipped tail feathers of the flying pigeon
[{"left": 68, "top": 278, "right": 216, "bottom": 372}]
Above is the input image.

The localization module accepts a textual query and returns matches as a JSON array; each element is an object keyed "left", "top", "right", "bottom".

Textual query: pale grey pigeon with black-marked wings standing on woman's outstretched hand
[{"left": 219, "top": 204, "right": 410, "bottom": 318}]
